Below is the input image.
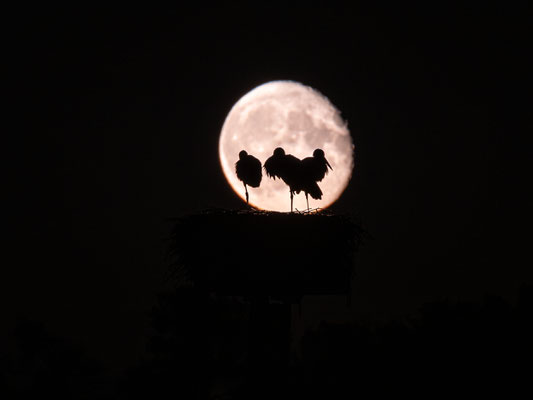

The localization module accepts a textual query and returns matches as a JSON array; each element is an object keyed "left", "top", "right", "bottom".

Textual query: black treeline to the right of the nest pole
[{"left": 301, "top": 286, "right": 533, "bottom": 398}]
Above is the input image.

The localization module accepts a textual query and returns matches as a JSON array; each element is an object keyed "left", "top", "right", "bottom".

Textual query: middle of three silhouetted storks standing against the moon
[{"left": 264, "top": 147, "right": 302, "bottom": 212}]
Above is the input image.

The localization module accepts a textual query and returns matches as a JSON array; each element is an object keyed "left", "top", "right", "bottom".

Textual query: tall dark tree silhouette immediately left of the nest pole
[{"left": 121, "top": 287, "right": 248, "bottom": 399}]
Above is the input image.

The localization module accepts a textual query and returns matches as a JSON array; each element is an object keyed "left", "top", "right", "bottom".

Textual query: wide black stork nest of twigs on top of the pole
[{"left": 168, "top": 209, "right": 367, "bottom": 295}]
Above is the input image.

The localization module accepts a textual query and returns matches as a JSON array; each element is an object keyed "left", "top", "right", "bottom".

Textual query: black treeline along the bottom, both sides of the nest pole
[{"left": 0, "top": 286, "right": 533, "bottom": 399}]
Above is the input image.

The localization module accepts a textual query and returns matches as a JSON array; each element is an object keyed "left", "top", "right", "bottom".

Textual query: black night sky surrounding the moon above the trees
[{"left": 1, "top": 5, "right": 533, "bottom": 372}]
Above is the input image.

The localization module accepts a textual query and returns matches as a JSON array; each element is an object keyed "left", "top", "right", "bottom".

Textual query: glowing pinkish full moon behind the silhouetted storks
[{"left": 219, "top": 81, "right": 354, "bottom": 211}]
